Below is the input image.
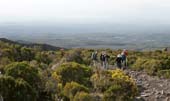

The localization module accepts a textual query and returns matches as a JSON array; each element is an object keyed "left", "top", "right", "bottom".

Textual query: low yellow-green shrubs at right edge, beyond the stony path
[{"left": 131, "top": 51, "right": 170, "bottom": 78}]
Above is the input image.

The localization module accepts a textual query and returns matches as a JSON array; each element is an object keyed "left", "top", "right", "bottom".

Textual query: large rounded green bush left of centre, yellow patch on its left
[{"left": 53, "top": 62, "right": 92, "bottom": 86}]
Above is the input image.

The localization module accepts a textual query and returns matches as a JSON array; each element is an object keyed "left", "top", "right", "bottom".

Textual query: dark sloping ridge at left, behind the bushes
[{"left": 0, "top": 38, "right": 62, "bottom": 51}]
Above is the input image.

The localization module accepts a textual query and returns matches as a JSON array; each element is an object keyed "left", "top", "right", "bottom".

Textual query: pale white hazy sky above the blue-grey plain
[{"left": 0, "top": 0, "right": 170, "bottom": 25}]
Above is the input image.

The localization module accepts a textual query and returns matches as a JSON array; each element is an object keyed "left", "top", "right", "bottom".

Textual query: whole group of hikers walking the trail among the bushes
[{"left": 91, "top": 49, "right": 128, "bottom": 69}]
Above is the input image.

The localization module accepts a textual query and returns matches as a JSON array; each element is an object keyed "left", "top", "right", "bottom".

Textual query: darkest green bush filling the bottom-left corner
[{"left": 0, "top": 76, "right": 37, "bottom": 101}]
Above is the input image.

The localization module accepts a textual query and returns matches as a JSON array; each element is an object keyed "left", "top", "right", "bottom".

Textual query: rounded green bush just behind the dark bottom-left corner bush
[{"left": 5, "top": 62, "right": 40, "bottom": 89}]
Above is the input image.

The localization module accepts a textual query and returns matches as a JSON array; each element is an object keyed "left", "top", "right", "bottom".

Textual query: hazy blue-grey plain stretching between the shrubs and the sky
[{"left": 0, "top": 25, "right": 170, "bottom": 50}]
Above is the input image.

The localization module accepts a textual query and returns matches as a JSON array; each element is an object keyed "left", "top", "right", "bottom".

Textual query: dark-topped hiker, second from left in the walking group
[{"left": 100, "top": 52, "right": 110, "bottom": 69}]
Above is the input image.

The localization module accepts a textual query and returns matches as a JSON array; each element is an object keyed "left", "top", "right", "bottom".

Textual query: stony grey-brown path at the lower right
[{"left": 125, "top": 70, "right": 170, "bottom": 101}]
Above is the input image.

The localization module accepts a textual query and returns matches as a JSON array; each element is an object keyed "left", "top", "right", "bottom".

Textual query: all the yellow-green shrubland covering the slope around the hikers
[{"left": 0, "top": 39, "right": 170, "bottom": 101}]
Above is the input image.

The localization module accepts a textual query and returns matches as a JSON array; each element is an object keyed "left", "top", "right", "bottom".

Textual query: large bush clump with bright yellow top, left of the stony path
[{"left": 91, "top": 69, "right": 138, "bottom": 101}]
